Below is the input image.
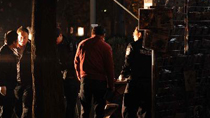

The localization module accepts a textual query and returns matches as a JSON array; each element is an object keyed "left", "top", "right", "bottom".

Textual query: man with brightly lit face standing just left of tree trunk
[{"left": 15, "top": 26, "right": 33, "bottom": 118}]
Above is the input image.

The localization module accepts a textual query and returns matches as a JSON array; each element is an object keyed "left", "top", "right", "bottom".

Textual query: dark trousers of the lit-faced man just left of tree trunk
[{"left": 15, "top": 85, "right": 33, "bottom": 118}]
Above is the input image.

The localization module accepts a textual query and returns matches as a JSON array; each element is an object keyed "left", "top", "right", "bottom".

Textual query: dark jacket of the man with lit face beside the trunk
[{"left": 20, "top": 42, "right": 32, "bottom": 86}]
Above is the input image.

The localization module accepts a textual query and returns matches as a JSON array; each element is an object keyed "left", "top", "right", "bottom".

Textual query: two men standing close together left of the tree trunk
[{"left": 0, "top": 27, "right": 33, "bottom": 118}]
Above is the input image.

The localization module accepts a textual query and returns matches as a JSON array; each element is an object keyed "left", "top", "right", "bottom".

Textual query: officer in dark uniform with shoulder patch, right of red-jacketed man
[{"left": 119, "top": 28, "right": 151, "bottom": 118}]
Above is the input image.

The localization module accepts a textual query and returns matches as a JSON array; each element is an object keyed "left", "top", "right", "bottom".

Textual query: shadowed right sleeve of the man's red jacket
[{"left": 104, "top": 46, "right": 114, "bottom": 89}]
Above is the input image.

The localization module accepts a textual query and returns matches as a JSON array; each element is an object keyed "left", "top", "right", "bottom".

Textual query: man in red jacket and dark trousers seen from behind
[{"left": 74, "top": 26, "right": 114, "bottom": 118}]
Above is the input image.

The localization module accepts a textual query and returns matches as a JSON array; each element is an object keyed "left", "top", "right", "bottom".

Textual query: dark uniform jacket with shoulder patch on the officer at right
[{"left": 121, "top": 39, "right": 151, "bottom": 79}]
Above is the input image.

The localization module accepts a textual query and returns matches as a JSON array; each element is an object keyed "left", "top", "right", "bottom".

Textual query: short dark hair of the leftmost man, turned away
[{"left": 4, "top": 30, "right": 18, "bottom": 45}]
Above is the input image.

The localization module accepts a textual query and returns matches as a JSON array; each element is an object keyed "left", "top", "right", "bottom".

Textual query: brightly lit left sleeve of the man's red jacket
[{"left": 74, "top": 45, "right": 81, "bottom": 80}]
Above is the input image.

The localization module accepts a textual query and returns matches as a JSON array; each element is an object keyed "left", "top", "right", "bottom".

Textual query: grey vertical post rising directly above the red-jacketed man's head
[{"left": 90, "top": 0, "right": 96, "bottom": 29}]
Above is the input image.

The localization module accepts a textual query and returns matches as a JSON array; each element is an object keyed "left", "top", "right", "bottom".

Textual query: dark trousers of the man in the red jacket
[{"left": 80, "top": 78, "right": 107, "bottom": 118}]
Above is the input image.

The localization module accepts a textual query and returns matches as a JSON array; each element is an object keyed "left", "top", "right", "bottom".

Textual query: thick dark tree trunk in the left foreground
[{"left": 32, "top": 0, "right": 64, "bottom": 118}]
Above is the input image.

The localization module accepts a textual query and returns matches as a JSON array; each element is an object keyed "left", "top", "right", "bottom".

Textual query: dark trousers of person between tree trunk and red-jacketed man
[{"left": 64, "top": 78, "right": 79, "bottom": 118}]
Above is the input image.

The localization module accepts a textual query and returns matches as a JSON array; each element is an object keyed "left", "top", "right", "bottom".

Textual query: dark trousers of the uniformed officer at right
[{"left": 122, "top": 81, "right": 151, "bottom": 118}]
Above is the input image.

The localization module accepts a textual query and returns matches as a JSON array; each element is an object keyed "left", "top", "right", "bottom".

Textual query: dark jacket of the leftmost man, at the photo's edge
[{"left": 0, "top": 45, "right": 18, "bottom": 89}]
